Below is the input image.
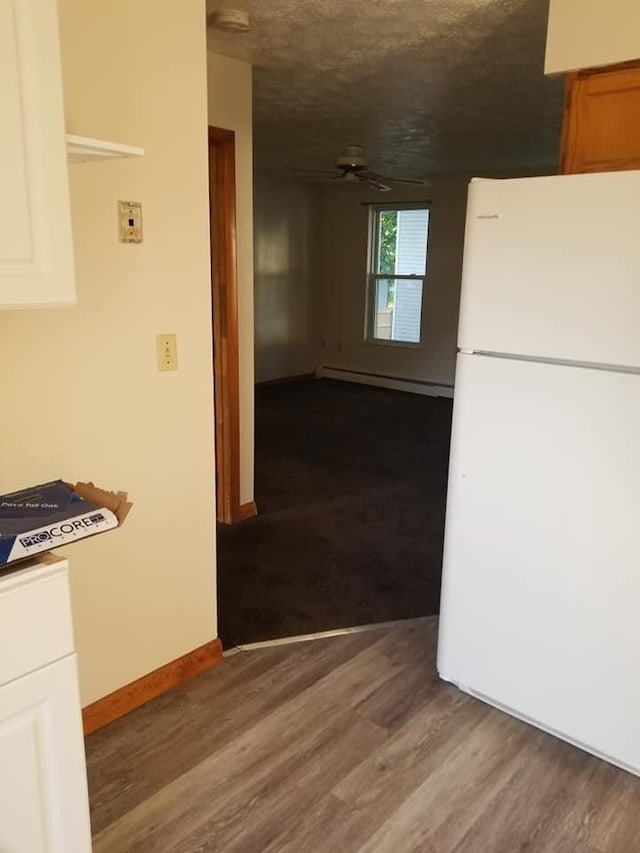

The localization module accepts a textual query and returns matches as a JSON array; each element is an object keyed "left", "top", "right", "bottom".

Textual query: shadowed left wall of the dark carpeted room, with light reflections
[{"left": 254, "top": 174, "right": 318, "bottom": 382}]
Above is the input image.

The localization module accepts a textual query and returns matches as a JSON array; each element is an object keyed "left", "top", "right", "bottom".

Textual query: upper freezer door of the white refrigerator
[{"left": 458, "top": 171, "right": 640, "bottom": 366}]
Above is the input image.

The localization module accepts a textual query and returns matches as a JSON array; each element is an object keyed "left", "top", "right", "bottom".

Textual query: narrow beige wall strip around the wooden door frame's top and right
[{"left": 207, "top": 53, "right": 254, "bottom": 503}]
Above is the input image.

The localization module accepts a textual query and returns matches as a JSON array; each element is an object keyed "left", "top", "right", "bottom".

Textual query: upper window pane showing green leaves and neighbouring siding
[{"left": 374, "top": 208, "right": 429, "bottom": 275}]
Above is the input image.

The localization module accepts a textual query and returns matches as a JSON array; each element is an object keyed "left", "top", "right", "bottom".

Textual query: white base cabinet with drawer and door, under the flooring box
[{"left": 0, "top": 555, "right": 91, "bottom": 853}]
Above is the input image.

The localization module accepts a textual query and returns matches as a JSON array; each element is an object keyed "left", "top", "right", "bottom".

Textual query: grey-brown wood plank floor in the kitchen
[{"left": 87, "top": 617, "right": 640, "bottom": 853}]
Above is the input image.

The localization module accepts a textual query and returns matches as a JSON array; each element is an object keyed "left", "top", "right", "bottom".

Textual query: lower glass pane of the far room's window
[{"left": 373, "top": 278, "right": 422, "bottom": 344}]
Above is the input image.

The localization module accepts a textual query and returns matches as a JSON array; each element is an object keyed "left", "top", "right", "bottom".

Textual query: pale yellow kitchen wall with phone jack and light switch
[{"left": 0, "top": 0, "right": 218, "bottom": 704}]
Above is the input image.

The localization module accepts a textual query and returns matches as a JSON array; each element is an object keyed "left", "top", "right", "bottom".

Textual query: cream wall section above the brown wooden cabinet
[{"left": 545, "top": 0, "right": 640, "bottom": 74}]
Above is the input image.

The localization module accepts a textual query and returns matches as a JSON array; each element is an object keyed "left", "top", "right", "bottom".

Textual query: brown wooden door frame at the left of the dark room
[{"left": 209, "top": 127, "right": 244, "bottom": 524}]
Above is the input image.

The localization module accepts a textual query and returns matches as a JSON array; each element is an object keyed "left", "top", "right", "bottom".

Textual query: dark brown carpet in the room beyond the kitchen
[{"left": 218, "top": 379, "right": 451, "bottom": 649}]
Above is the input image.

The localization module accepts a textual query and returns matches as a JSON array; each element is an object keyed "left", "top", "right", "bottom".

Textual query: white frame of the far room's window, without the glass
[{"left": 364, "top": 201, "right": 431, "bottom": 349}]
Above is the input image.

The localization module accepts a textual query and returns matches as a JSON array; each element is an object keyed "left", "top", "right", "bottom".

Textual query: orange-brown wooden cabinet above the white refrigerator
[{"left": 560, "top": 63, "right": 640, "bottom": 174}]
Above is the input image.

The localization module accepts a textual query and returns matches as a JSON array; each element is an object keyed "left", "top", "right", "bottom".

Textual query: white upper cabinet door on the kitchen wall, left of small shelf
[{"left": 0, "top": 0, "right": 75, "bottom": 308}]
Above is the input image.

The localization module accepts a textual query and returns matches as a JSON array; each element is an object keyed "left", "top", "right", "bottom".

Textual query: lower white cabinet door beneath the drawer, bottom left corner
[{"left": 0, "top": 655, "right": 91, "bottom": 853}]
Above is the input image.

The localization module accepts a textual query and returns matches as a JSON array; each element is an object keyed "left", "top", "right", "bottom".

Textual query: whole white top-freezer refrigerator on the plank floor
[{"left": 438, "top": 172, "right": 640, "bottom": 774}]
